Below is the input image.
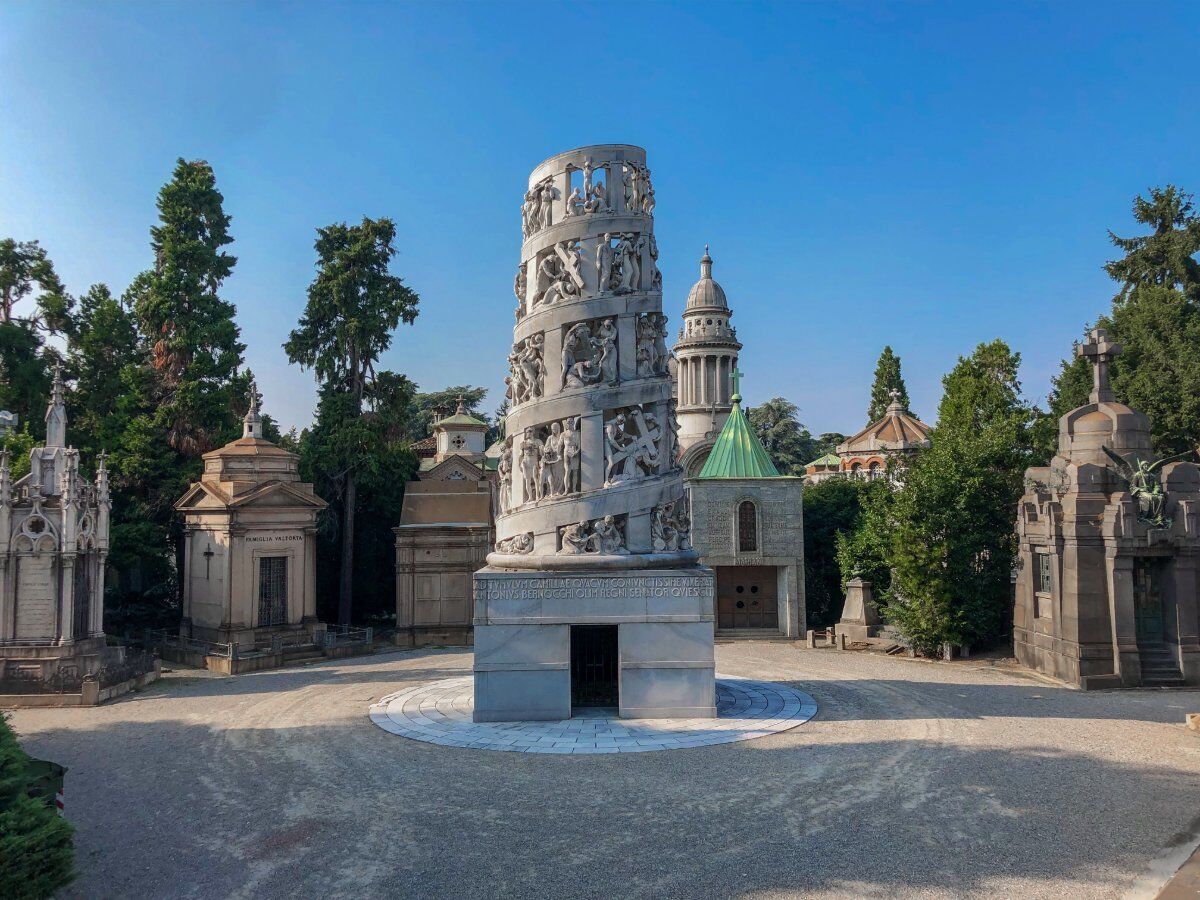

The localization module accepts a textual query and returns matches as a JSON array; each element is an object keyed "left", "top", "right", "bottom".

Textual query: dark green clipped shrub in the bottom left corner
[{"left": 0, "top": 715, "right": 74, "bottom": 900}]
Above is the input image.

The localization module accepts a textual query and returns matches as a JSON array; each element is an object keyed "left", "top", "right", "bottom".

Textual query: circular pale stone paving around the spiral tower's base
[{"left": 371, "top": 676, "right": 817, "bottom": 755}]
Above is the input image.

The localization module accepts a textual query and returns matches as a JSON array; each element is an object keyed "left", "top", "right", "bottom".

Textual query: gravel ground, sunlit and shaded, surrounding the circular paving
[{"left": 13, "top": 642, "right": 1200, "bottom": 900}]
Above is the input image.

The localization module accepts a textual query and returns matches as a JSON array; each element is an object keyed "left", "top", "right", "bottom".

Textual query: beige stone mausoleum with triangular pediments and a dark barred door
[{"left": 175, "top": 384, "right": 325, "bottom": 649}]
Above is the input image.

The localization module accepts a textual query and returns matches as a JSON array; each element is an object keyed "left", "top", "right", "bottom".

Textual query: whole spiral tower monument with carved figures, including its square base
[{"left": 474, "top": 144, "right": 715, "bottom": 721}]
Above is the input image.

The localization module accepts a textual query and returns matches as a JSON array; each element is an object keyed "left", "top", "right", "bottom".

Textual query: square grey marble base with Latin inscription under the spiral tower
[{"left": 474, "top": 566, "right": 716, "bottom": 722}]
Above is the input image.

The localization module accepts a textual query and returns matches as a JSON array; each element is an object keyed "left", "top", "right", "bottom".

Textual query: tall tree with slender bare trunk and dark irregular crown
[{"left": 283, "top": 217, "right": 420, "bottom": 625}]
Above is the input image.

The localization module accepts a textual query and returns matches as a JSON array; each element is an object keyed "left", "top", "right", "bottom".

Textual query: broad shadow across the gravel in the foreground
[{"left": 11, "top": 710, "right": 1200, "bottom": 899}]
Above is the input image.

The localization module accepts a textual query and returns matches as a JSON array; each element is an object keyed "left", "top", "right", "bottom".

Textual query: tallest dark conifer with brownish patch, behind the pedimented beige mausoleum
[{"left": 108, "top": 160, "right": 246, "bottom": 624}]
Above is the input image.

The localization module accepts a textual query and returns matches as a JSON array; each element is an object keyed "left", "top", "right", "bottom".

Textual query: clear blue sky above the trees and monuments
[{"left": 0, "top": 0, "right": 1200, "bottom": 432}]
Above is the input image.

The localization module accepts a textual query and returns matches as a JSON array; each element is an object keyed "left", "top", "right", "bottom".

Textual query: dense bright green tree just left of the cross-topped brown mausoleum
[{"left": 883, "top": 340, "right": 1033, "bottom": 653}]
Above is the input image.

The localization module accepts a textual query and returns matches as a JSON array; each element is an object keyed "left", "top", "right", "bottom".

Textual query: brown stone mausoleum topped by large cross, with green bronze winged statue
[{"left": 1013, "top": 329, "right": 1200, "bottom": 689}]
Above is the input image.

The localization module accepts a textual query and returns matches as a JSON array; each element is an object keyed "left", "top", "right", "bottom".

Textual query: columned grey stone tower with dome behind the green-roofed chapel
[{"left": 674, "top": 245, "right": 742, "bottom": 476}]
